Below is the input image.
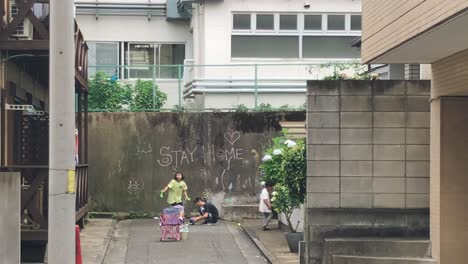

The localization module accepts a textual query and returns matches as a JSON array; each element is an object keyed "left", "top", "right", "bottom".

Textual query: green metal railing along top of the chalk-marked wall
[{"left": 89, "top": 60, "right": 355, "bottom": 111}]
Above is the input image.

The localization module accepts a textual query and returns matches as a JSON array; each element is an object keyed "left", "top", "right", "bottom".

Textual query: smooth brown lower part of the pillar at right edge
[{"left": 431, "top": 97, "right": 468, "bottom": 264}]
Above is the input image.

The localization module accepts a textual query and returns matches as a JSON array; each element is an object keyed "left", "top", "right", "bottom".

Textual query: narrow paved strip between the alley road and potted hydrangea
[{"left": 243, "top": 219, "right": 299, "bottom": 264}]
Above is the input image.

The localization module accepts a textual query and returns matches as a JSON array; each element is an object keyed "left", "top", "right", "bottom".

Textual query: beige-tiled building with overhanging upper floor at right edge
[{"left": 362, "top": 0, "right": 468, "bottom": 264}]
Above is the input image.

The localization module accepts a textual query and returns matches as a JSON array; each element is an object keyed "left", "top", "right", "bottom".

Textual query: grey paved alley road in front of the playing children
[{"left": 82, "top": 219, "right": 267, "bottom": 264}]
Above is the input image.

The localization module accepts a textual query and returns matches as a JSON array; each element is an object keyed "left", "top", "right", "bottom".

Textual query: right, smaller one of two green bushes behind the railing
[{"left": 130, "top": 80, "right": 167, "bottom": 111}]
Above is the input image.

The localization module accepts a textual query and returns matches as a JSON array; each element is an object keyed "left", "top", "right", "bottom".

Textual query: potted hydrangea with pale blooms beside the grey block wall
[{"left": 261, "top": 136, "right": 307, "bottom": 252}]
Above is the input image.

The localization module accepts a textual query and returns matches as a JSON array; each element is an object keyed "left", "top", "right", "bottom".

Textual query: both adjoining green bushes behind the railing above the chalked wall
[{"left": 88, "top": 72, "right": 167, "bottom": 111}]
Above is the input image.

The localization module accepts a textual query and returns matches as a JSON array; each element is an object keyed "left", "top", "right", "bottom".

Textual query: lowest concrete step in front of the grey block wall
[{"left": 332, "top": 255, "right": 437, "bottom": 264}]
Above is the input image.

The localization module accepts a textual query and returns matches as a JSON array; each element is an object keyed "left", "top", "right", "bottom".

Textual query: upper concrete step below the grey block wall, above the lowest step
[{"left": 324, "top": 238, "right": 431, "bottom": 263}]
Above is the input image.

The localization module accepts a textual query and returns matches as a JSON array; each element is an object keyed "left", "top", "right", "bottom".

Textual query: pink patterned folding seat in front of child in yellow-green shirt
[{"left": 159, "top": 206, "right": 183, "bottom": 241}]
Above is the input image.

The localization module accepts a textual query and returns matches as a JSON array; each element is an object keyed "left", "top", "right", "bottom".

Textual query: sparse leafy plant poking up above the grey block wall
[{"left": 321, "top": 62, "right": 379, "bottom": 80}]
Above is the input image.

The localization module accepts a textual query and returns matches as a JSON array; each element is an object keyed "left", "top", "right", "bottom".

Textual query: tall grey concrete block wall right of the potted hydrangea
[{"left": 307, "top": 81, "right": 430, "bottom": 263}]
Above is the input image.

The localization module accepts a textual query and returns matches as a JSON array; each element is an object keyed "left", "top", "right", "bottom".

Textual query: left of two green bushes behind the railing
[{"left": 88, "top": 72, "right": 132, "bottom": 110}]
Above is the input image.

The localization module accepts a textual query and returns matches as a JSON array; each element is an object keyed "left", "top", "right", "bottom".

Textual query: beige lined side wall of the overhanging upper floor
[{"left": 362, "top": 0, "right": 468, "bottom": 62}]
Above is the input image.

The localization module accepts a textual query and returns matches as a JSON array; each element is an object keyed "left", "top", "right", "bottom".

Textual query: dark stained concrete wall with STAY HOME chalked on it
[{"left": 89, "top": 113, "right": 305, "bottom": 212}]
